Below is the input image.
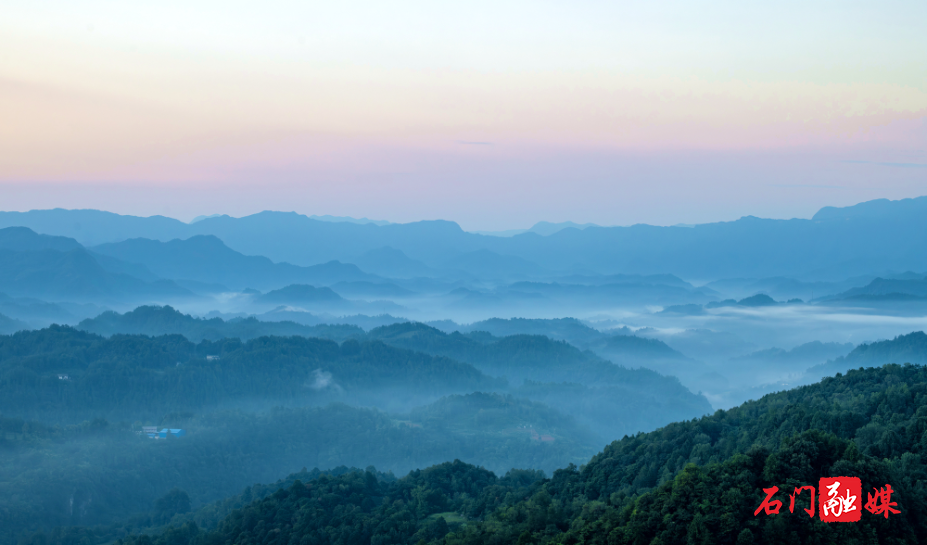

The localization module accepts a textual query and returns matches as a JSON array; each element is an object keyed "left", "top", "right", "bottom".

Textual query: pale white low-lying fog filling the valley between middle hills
[{"left": 116, "top": 280, "right": 927, "bottom": 409}]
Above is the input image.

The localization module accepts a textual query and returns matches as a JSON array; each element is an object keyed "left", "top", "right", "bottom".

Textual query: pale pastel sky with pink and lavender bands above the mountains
[{"left": 0, "top": 0, "right": 927, "bottom": 230}]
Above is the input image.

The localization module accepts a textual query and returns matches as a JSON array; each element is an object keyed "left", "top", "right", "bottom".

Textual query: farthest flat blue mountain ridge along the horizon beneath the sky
[{"left": 0, "top": 197, "right": 927, "bottom": 279}]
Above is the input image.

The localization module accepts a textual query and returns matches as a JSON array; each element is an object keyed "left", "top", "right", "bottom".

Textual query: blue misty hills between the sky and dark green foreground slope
[{"left": 0, "top": 199, "right": 927, "bottom": 544}]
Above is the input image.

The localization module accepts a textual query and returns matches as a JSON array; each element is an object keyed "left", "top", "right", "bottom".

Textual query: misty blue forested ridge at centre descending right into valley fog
[{"left": 368, "top": 322, "right": 711, "bottom": 441}]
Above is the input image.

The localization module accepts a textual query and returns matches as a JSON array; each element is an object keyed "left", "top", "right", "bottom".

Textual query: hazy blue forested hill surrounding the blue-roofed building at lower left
[{"left": 0, "top": 394, "right": 601, "bottom": 543}]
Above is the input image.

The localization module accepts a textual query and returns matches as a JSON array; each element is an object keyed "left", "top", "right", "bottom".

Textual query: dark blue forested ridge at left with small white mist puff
[{"left": 0, "top": 326, "right": 502, "bottom": 422}]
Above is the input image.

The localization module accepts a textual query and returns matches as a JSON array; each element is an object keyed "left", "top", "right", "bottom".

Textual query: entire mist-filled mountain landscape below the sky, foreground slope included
[{"left": 0, "top": 197, "right": 927, "bottom": 545}]
